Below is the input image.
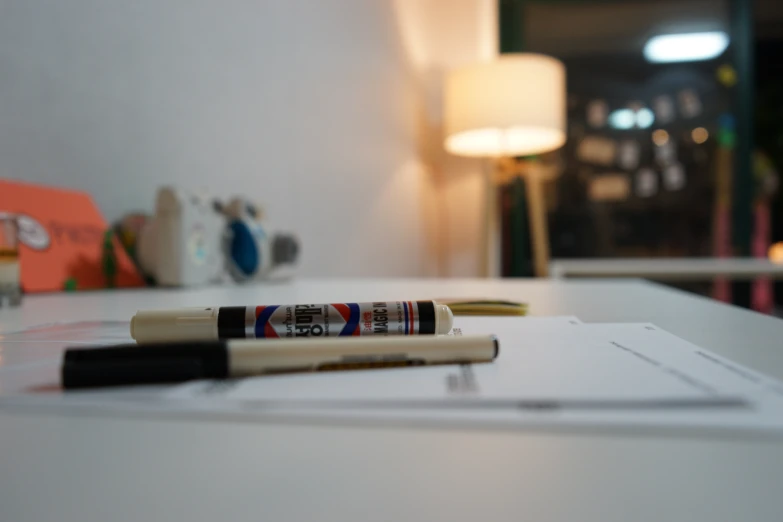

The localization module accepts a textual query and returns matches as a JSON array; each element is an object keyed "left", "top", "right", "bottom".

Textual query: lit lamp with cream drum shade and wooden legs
[{"left": 444, "top": 53, "right": 566, "bottom": 276}]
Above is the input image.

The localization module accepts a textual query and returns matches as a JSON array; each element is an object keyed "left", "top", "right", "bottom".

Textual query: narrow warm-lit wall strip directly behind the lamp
[{"left": 395, "top": 0, "right": 498, "bottom": 277}]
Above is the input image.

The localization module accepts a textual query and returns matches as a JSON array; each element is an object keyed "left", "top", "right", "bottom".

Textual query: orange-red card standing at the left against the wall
[{"left": 0, "top": 179, "right": 144, "bottom": 292}]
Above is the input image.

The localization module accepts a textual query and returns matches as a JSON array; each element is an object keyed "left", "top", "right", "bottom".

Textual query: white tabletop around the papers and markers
[{"left": 0, "top": 280, "right": 783, "bottom": 522}]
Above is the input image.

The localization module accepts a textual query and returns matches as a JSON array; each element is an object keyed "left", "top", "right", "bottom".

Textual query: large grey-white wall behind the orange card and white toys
[{"left": 0, "top": 0, "right": 440, "bottom": 276}]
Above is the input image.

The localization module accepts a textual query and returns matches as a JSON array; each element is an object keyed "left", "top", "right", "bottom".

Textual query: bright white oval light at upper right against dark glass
[{"left": 644, "top": 31, "right": 729, "bottom": 63}]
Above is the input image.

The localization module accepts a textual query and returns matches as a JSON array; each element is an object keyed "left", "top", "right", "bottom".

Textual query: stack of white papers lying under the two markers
[{"left": 0, "top": 317, "right": 783, "bottom": 436}]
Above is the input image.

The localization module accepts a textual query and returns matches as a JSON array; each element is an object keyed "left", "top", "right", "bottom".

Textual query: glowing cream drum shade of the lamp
[{"left": 444, "top": 53, "right": 566, "bottom": 157}]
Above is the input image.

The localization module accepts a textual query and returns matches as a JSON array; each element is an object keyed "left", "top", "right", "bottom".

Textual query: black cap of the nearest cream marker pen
[{"left": 62, "top": 341, "right": 228, "bottom": 389}]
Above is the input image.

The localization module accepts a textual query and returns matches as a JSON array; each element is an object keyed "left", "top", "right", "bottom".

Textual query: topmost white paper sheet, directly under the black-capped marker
[{"left": 168, "top": 317, "right": 741, "bottom": 408}]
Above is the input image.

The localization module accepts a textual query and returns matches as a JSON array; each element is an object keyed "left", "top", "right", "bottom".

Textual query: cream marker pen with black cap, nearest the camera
[{"left": 62, "top": 335, "right": 499, "bottom": 389}]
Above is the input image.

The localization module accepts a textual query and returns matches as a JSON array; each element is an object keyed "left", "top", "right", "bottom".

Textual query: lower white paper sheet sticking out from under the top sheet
[{"left": 258, "top": 324, "right": 783, "bottom": 438}]
